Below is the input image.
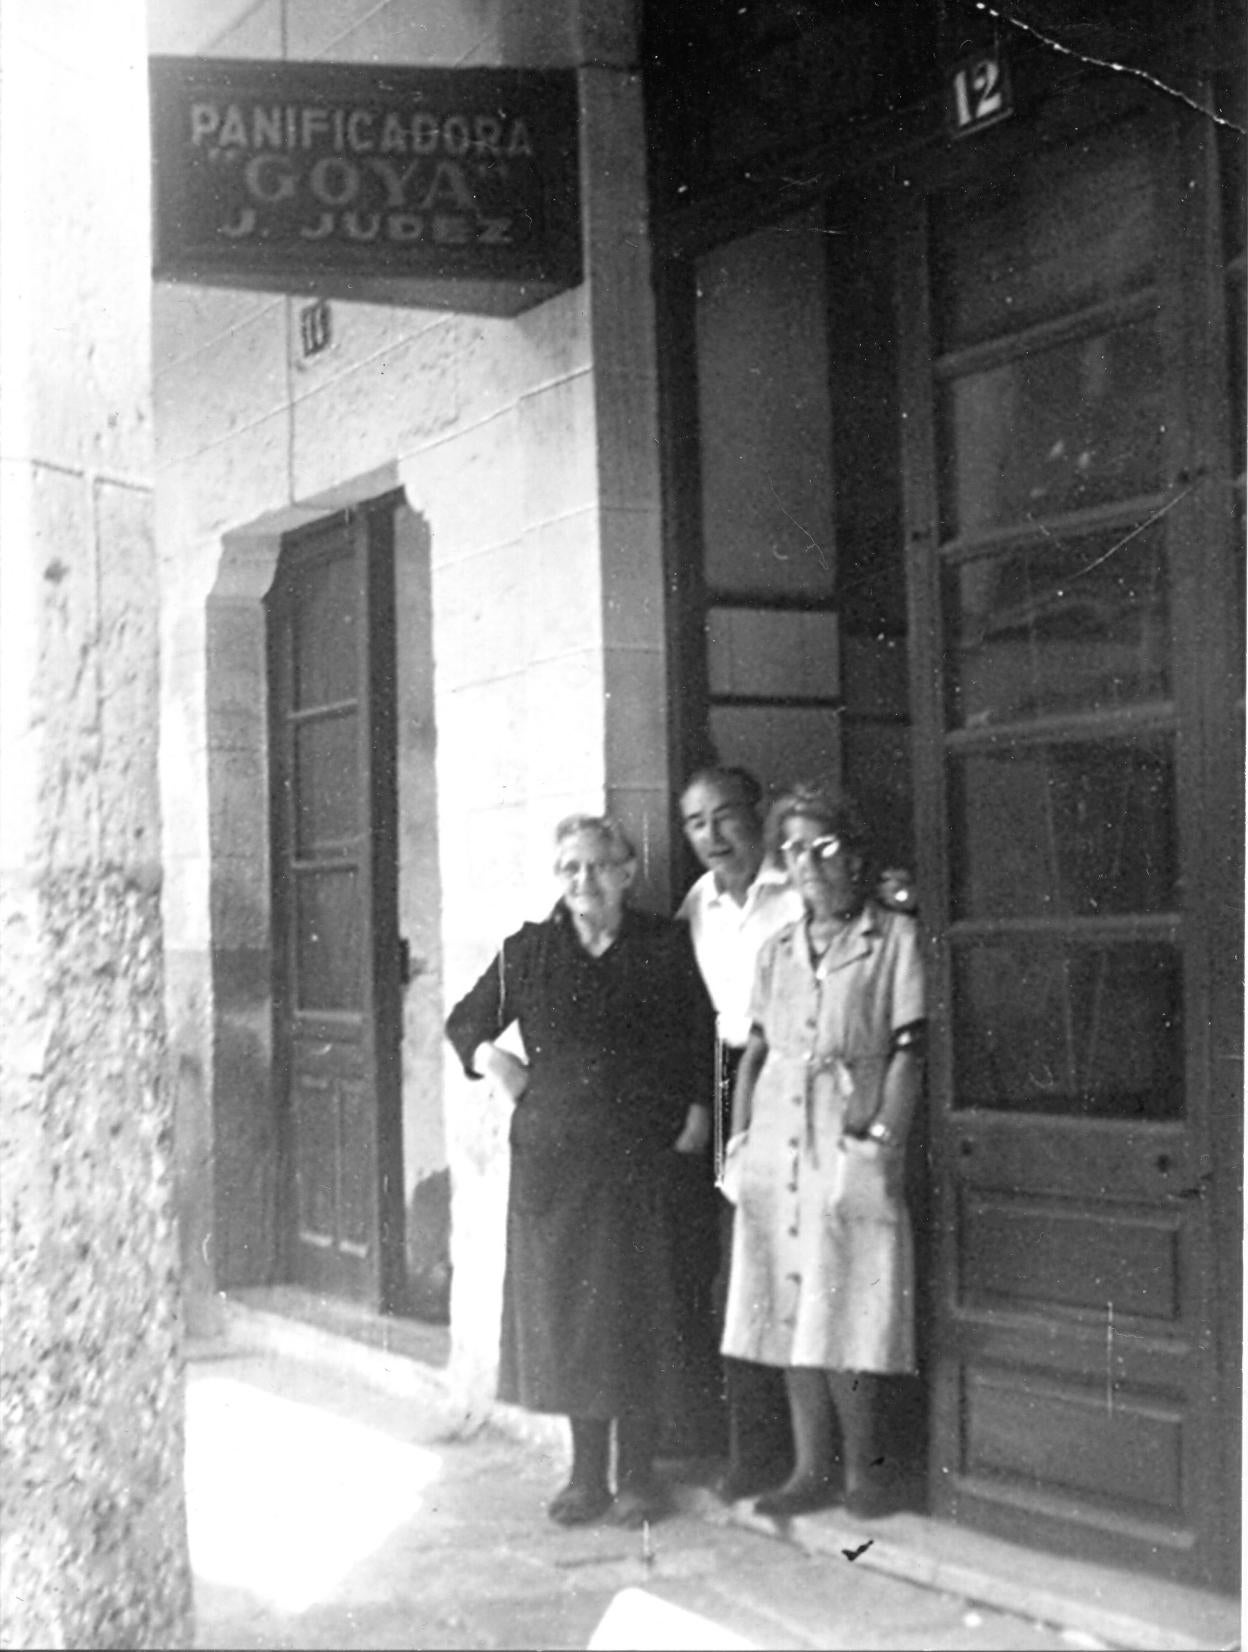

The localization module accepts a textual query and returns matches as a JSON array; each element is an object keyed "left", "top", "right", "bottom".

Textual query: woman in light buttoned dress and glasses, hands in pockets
[{"left": 722, "top": 783, "right": 924, "bottom": 1518}]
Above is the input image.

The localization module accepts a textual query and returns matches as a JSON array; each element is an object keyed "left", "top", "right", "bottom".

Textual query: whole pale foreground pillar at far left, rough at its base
[{"left": 0, "top": 0, "right": 192, "bottom": 1647}]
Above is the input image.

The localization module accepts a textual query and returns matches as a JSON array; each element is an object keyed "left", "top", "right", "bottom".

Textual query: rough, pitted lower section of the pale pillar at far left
[{"left": 0, "top": 867, "right": 190, "bottom": 1647}]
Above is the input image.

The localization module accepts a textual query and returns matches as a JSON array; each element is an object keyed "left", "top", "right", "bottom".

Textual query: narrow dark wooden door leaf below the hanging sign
[{"left": 269, "top": 502, "right": 403, "bottom": 1308}]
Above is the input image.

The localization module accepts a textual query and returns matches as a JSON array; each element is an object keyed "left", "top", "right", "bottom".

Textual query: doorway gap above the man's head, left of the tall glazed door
[{"left": 687, "top": 193, "right": 911, "bottom": 864}]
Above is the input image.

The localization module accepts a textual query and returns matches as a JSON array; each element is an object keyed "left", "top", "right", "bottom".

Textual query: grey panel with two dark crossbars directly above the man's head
[{"left": 686, "top": 208, "right": 843, "bottom": 790}]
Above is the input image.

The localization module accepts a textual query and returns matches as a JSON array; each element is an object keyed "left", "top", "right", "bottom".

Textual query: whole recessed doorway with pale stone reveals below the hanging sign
[{"left": 205, "top": 492, "right": 450, "bottom": 1335}]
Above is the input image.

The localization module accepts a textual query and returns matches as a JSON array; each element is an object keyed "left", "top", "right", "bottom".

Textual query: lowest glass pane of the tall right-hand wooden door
[{"left": 954, "top": 935, "right": 1184, "bottom": 1118}]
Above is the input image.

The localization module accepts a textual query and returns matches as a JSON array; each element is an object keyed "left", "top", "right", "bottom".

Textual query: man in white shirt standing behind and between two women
[{"left": 676, "top": 768, "right": 803, "bottom": 1502}]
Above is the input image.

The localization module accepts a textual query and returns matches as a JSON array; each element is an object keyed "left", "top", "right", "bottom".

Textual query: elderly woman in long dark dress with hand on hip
[{"left": 446, "top": 814, "right": 714, "bottom": 1525}]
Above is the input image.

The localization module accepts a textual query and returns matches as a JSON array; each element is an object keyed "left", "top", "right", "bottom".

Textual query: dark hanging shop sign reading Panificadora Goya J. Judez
[{"left": 150, "top": 58, "right": 582, "bottom": 316}]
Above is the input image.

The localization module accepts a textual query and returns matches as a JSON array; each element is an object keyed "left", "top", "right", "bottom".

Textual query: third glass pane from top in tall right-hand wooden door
[{"left": 944, "top": 527, "right": 1170, "bottom": 729}]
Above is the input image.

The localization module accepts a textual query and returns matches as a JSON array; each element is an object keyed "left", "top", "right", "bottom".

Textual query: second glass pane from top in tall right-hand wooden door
[{"left": 939, "top": 320, "right": 1164, "bottom": 535}]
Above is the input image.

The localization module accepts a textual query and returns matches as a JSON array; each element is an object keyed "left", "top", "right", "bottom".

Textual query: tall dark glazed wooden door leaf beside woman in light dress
[{"left": 899, "top": 90, "right": 1238, "bottom": 1581}]
